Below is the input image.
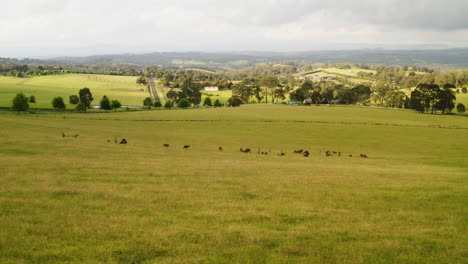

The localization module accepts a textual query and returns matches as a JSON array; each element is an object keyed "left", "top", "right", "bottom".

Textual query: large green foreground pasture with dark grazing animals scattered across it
[{"left": 0, "top": 105, "right": 468, "bottom": 264}]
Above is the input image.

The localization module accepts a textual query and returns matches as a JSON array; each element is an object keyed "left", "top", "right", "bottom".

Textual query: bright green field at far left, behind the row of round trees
[{"left": 0, "top": 74, "right": 149, "bottom": 108}]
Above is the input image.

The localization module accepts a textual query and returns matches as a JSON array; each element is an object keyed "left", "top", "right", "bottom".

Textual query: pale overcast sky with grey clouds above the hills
[{"left": 0, "top": 0, "right": 468, "bottom": 57}]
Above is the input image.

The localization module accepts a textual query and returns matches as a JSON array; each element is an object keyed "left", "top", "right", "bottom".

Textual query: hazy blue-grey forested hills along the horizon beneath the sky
[{"left": 2, "top": 48, "right": 468, "bottom": 70}]
